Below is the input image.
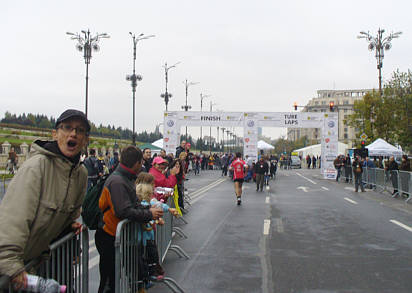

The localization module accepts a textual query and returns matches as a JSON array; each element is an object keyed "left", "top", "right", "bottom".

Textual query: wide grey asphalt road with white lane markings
[{"left": 146, "top": 169, "right": 412, "bottom": 293}]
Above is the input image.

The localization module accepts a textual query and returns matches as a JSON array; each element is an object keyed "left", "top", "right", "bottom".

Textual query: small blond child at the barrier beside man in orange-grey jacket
[{"left": 136, "top": 173, "right": 178, "bottom": 279}]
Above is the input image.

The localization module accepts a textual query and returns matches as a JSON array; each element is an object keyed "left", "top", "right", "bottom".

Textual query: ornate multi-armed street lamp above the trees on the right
[{"left": 358, "top": 29, "right": 402, "bottom": 95}]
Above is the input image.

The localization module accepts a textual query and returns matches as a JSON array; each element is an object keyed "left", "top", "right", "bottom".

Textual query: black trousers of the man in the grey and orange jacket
[{"left": 95, "top": 229, "right": 115, "bottom": 293}]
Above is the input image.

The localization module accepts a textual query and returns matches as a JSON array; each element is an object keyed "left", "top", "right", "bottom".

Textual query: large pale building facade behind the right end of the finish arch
[{"left": 288, "top": 89, "right": 372, "bottom": 148}]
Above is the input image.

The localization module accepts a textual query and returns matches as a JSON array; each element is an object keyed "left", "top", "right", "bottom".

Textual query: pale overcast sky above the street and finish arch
[{"left": 0, "top": 0, "right": 412, "bottom": 139}]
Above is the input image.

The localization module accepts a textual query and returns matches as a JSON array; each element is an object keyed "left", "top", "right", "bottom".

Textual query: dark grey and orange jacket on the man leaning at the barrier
[{"left": 99, "top": 164, "right": 152, "bottom": 236}]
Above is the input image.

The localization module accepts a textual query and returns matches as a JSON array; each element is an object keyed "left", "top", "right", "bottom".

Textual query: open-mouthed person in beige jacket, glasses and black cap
[{"left": 0, "top": 110, "right": 90, "bottom": 288}]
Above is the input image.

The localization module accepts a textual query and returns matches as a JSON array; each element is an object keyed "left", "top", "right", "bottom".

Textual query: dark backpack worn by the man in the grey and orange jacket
[{"left": 82, "top": 172, "right": 117, "bottom": 230}]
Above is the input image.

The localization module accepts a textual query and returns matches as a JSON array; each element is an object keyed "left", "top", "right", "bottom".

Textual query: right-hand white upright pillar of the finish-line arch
[{"left": 321, "top": 113, "right": 338, "bottom": 179}]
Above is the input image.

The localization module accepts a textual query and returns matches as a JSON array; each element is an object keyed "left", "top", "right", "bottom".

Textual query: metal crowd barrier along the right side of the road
[{"left": 341, "top": 167, "right": 412, "bottom": 202}]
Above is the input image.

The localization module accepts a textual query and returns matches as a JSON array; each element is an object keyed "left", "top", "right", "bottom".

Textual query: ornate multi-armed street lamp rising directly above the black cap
[{"left": 66, "top": 30, "right": 110, "bottom": 118}]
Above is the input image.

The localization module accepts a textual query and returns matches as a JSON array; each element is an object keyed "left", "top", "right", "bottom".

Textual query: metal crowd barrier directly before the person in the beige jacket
[{"left": 0, "top": 227, "right": 89, "bottom": 293}]
